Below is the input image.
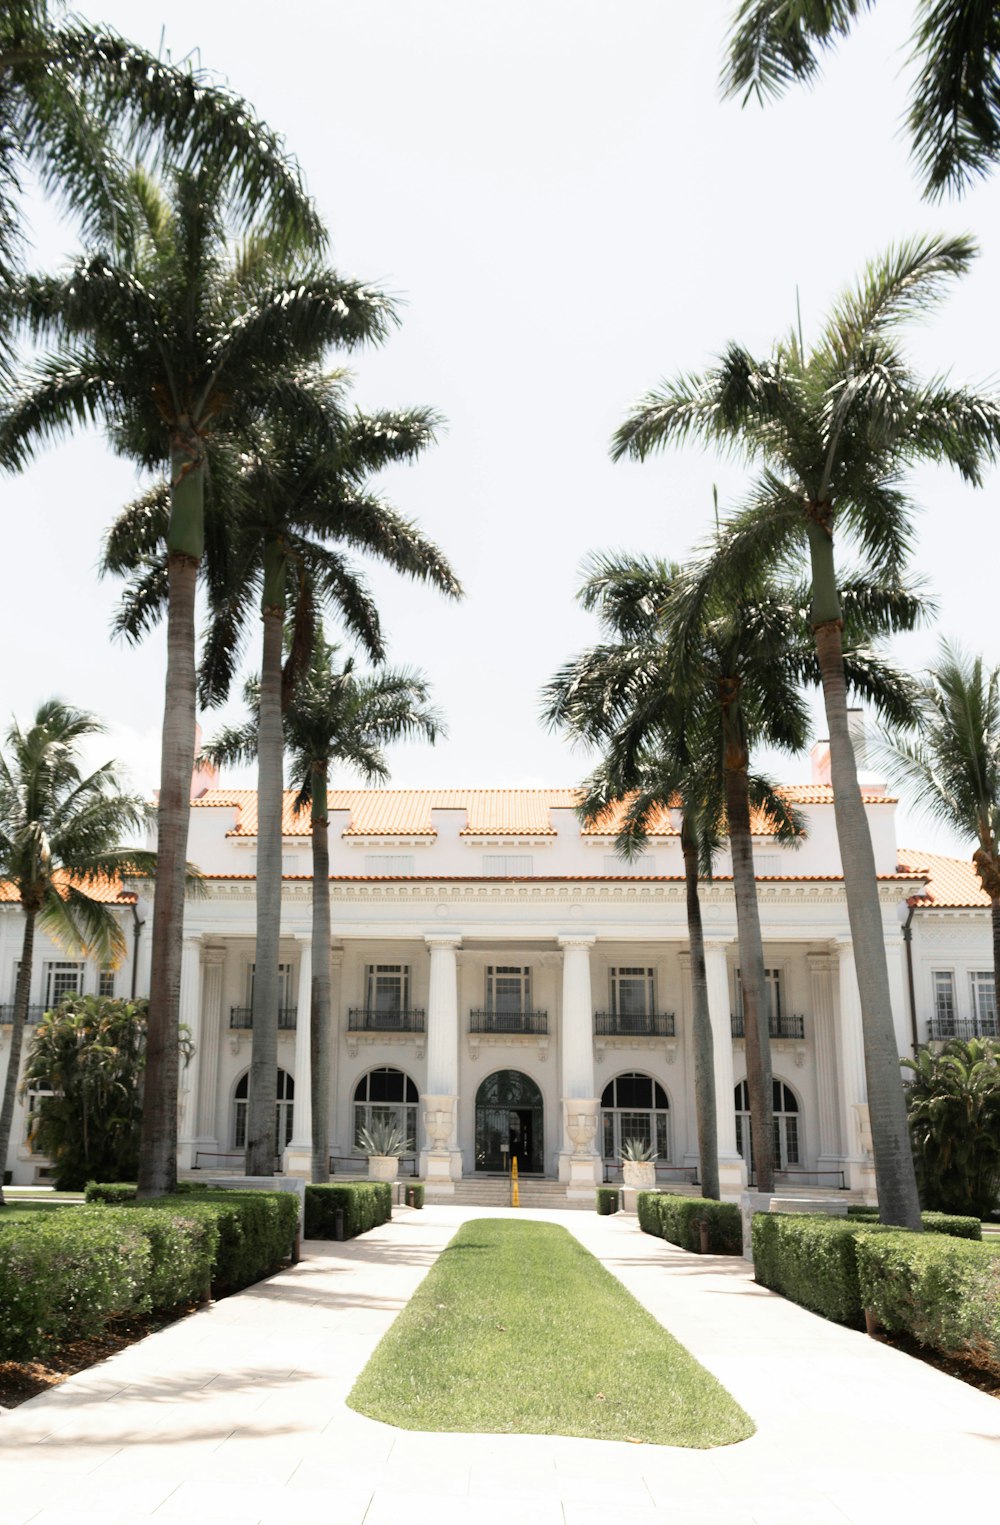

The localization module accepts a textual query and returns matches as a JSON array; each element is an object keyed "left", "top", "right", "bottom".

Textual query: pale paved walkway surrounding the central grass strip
[{"left": 0, "top": 1206, "right": 1000, "bottom": 1525}]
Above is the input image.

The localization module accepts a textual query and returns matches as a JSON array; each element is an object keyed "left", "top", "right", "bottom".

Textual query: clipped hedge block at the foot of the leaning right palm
[{"left": 752, "top": 1212, "right": 892, "bottom": 1328}]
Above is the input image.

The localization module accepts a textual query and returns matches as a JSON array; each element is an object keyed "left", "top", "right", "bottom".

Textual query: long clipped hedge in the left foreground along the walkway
[{"left": 0, "top": 1191, "right": 299, "bottom": 1360}]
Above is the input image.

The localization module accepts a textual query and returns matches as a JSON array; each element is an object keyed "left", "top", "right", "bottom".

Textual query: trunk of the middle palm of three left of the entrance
[{"left": 247, "top": 567, "right": 285, "bottom": 1176}]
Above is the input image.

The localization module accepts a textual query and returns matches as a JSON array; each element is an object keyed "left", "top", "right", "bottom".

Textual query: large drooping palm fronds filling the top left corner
[{"left": 0, "top": 0, "right": 325, "bottom": 278}]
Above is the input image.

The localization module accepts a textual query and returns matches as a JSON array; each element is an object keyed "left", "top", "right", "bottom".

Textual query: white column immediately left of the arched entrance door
[{"left": 421, "top": 932, "right": 462, "bottom": 1196}]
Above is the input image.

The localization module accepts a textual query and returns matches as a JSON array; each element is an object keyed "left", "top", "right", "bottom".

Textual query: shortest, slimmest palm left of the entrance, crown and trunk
[{"left": 204, "top": 630, "right": 442, "bottom": 1182}]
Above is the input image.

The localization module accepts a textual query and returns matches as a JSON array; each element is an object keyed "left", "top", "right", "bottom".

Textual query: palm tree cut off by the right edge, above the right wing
[{"left": 887, "top": 642, "right": 1000, "bottom": 1011}]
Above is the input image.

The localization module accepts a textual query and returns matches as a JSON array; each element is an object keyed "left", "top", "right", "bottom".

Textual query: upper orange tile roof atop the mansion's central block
[{"left": 191, "top": 784, "right": 895, "bottom": 837}]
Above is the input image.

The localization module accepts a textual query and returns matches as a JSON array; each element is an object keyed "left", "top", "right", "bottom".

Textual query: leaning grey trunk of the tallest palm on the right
[{"left": 809, "top": 522, "right": 922, "bottom": 1232}]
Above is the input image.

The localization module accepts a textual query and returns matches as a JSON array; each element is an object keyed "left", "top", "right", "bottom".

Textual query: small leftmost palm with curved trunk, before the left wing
[{"left": 0, "top": 698, "right": 155, "bottom": 1205}]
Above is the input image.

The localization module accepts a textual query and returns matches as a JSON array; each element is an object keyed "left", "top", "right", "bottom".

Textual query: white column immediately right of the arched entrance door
[{"left": 558, "top": 933, "right": 601, "bottom": 1199}]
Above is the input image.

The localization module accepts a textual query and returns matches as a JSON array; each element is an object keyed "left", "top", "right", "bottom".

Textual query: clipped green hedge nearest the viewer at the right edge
[{"left": 857, "top": 1231, "right": 1000, "bottom": 1360}]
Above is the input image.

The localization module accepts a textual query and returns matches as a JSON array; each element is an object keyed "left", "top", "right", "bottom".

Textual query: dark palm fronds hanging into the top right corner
[{"left": 723, "top": 0, "right": 1000, "bottom": 197}]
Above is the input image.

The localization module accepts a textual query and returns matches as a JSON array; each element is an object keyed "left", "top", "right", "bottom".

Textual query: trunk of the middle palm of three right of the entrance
[{"left": 720, "top": 679, "right": 776, "bottom": 1191}]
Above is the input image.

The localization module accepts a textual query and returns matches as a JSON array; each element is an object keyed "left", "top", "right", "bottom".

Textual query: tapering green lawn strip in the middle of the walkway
[{"left": 348, "top": 1218, "right": 755, "bottom": 1447}]
